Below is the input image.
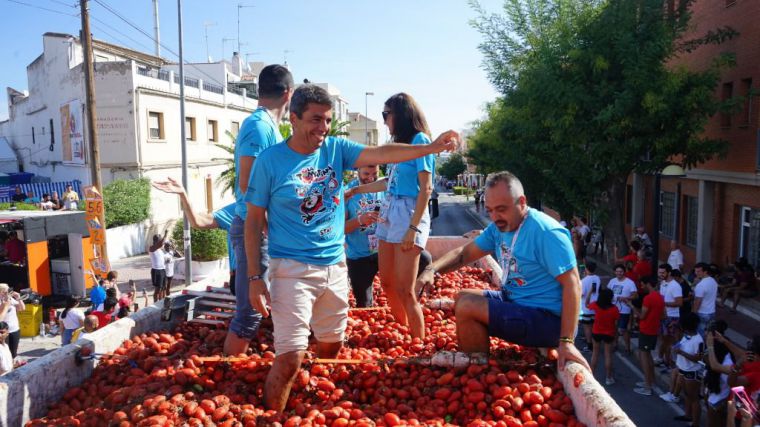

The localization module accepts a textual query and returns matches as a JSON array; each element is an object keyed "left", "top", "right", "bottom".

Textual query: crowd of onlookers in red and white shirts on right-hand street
[{"left": 571, "top": 224, "right": 760, "bottom": 426}]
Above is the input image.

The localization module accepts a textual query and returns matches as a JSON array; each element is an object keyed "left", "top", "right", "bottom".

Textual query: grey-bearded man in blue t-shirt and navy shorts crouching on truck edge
[{"left": 417, "top": 171, "right": 588, "bottom": 369}]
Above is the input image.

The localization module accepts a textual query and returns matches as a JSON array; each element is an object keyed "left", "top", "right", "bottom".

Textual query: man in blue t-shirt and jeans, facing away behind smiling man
[{"left": 224, "top": 65, "right": 294, "bottom": 355}]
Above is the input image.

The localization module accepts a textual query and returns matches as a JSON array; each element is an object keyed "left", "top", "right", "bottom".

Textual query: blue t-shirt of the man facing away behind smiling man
[{"left": 235, "top": 107, "right": 282, "bottom": 220}]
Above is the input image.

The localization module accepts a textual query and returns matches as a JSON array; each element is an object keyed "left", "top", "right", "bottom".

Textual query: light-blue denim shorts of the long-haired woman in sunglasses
[{"left": 375, "top": 196, "right": 430, "bottom": 249}]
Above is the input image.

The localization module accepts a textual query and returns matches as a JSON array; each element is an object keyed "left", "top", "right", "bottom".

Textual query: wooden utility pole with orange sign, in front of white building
[{"left": 79, "top": 0, "right": 108, "bottom": 259}]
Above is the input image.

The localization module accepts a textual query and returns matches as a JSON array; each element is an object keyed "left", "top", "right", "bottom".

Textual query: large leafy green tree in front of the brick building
[{"left": 469, "top": 0, "right": 736, "bottom": 258}]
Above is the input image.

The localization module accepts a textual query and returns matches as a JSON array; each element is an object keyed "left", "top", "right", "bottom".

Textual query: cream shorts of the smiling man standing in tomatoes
[{"left": 269, "top": 258, "right": 349, "bottom": 355}]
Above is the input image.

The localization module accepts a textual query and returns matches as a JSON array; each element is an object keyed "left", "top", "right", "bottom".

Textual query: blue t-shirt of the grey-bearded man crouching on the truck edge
[{"left": 475, "top": 208, "right": 575, "bottom": 315}]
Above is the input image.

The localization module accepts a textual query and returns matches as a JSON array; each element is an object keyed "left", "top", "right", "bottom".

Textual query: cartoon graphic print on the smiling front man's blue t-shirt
[{"left": 296, "top": 166, "right": 340, "bottom": 225}]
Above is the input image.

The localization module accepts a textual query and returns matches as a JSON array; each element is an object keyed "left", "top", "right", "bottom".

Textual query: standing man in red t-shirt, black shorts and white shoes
[{"left": 630, "top": 276, "right": 665, "bottom": 396}]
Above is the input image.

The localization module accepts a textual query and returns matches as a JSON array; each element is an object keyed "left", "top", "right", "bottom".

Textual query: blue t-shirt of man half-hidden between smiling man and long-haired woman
[{"left": 346, "top": 179, "right": 385, "bottom": 259}]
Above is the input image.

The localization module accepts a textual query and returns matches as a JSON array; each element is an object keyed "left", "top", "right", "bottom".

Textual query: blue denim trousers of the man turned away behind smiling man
[{"left": 230, "top": 216, "right": 269, "bottom": 338}]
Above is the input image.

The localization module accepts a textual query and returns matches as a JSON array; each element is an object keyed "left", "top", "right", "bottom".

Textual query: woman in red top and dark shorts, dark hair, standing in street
[{"left": 585, "top": 288, "right": 620, "bottom": 385}]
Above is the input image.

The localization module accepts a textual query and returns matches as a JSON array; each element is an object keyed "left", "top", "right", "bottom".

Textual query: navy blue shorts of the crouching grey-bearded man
[{"left": 483, "top": 290, "right": 560, "bottom": 347}]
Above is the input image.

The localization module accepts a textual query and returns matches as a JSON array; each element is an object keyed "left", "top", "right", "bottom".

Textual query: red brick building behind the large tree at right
[{"left": 625, "top": 0, "right": 760, "bottom": 269}]
